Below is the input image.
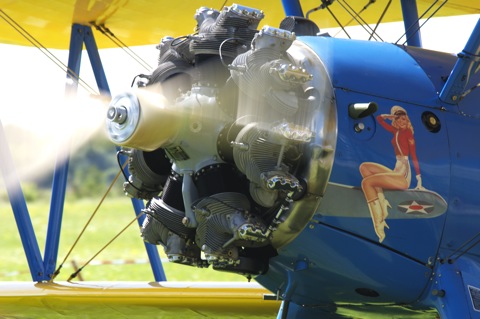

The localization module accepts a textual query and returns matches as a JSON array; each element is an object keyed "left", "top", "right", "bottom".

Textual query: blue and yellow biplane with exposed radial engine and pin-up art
[{"left": 0, "top": 0, "right": 480, "bottom": 319}]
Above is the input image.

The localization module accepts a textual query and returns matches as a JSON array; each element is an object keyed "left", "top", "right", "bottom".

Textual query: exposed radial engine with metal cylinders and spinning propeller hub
[{"left": 107, "top": 4, "right": 336, "bottom": 276}]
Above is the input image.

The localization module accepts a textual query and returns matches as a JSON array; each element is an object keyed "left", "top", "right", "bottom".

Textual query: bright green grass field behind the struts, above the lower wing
[{"left": 0, "top": 195, "right": 246, "bottom": 281}]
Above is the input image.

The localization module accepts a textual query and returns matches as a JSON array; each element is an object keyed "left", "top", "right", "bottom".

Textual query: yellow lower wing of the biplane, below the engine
[{"left": 0, "top": 282, "right": 280, "bottom": 319}]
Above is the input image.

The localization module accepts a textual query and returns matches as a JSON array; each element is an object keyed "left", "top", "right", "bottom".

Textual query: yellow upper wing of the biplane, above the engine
[{"left": 0, "top": 0, "right": 480, "bottom": 49}]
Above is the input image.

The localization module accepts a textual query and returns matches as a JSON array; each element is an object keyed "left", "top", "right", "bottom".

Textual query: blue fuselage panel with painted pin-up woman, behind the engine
[{"left": 257, "top": 37, "right": 480, "bottom": 318}]
